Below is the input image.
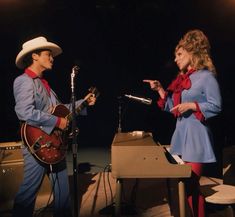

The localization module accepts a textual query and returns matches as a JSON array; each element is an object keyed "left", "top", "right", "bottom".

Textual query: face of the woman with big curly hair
[{"left": 175, "top": 47, "right": 192, "bottom": 71}]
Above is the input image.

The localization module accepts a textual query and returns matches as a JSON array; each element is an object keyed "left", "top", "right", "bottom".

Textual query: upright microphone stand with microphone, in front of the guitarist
[{"left": 71, "top": 66, "right": 78, "bottom": 217}]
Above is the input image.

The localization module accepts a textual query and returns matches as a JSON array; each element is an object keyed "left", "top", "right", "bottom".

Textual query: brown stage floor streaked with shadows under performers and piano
[{"left": 0, "top": 147, "right": 231, "bottom": 217}]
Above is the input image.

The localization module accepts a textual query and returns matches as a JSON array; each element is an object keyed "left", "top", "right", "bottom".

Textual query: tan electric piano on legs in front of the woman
[{"left": 111, "top": 131, "right": 191, "bottom": 217}]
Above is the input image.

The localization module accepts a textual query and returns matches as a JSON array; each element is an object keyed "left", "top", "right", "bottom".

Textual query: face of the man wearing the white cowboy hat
[{"left": 33, "top": 50, "right": 54, "bottom": 70}]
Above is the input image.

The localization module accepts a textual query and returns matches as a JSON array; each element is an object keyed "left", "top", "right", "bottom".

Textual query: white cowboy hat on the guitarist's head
[{"left": 15, "top": 36, "right": 62, "bottom": 69}]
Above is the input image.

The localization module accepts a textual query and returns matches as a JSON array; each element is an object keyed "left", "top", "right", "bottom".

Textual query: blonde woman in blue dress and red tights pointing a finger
[{"left": 144, "top": 29, "right": 221, "bottom": 217}]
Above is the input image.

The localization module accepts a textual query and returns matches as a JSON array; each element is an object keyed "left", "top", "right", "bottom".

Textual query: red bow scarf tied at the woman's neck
[{"left": 167, "top": 69, "right": 196, "bottom": 117}]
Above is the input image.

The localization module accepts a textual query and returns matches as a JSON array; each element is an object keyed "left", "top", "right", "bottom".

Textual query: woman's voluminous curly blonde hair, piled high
[{"left": 175, "top": 29, "right": 216, "bottom": 74}]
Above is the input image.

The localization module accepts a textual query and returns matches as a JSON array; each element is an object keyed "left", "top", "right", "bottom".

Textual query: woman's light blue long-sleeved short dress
[{"left": 164, "top": 70, "right": 222, "bottom": 163}]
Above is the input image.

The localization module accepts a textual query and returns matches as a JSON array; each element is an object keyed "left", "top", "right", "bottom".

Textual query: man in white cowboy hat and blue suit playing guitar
[{"left": 13, "top": 37, "right": 96, "bottom": 217}]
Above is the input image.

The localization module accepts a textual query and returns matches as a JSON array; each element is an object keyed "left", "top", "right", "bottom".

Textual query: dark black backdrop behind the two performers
[{"left": 0, "top": 0, "right": 235, "bottom": 153}]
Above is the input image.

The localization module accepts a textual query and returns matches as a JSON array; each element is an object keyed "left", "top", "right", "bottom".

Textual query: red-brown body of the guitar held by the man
[{"left": 21, "top": 105, "right": 70, "bottom": 164}]
